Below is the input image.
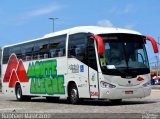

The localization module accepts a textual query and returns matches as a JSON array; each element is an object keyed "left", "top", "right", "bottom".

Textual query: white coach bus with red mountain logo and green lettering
[{"left": 1, "top": 26, "right": 158, "bottom": 104}]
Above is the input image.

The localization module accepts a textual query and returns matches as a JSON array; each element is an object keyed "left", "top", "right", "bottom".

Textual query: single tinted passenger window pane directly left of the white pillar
[{"left": 49, "top": 34, "right": 67, "bottom": 58}]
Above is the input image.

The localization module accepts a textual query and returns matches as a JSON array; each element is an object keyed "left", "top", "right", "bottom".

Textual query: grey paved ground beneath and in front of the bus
[{"left": 0, "top": 89, "right": 160, "bottom": 118}]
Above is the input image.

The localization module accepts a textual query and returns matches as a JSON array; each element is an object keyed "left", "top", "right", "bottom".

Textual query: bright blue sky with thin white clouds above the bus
[{"left": 0, "top": 0, "right": 160, "bottom": 65}]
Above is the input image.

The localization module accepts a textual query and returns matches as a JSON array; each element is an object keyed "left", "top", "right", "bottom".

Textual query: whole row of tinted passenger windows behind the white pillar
[{"left": 3, "top": 34, "right": 67, "bottom": 64}]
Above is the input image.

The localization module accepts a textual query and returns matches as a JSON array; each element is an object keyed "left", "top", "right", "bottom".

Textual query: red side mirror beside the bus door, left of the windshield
[{"left": 90, "top": 35, "right": 104, "bottom": 54}]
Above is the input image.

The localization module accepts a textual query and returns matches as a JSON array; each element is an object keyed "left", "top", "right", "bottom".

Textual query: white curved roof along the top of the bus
[{"left": 3, "top": 26, "right": 141, "bottom": 48}]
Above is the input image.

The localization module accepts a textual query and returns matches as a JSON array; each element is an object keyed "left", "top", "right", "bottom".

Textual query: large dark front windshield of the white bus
[{"left": 99, "top": 34, "right": 149, "bottom": 75}]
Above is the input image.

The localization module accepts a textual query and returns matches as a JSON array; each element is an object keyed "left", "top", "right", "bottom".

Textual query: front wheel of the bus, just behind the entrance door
[{"left": 68, "top": 84, "right": 79, "bottom": 104}]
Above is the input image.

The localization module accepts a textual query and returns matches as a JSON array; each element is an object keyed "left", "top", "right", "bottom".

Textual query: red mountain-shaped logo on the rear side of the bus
[{"left": 3, "top": 54, "right": 29, "bottom": 88}]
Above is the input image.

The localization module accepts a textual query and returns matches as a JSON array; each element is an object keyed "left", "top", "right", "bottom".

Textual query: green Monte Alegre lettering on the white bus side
[{"left": 27, "top": 60, "right": 65, "bottom": 95}]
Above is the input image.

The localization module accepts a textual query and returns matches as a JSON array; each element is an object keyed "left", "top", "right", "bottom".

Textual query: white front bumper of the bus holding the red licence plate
[{"left": 100, "top": 86, "right": 151, "bottom": 99}]
